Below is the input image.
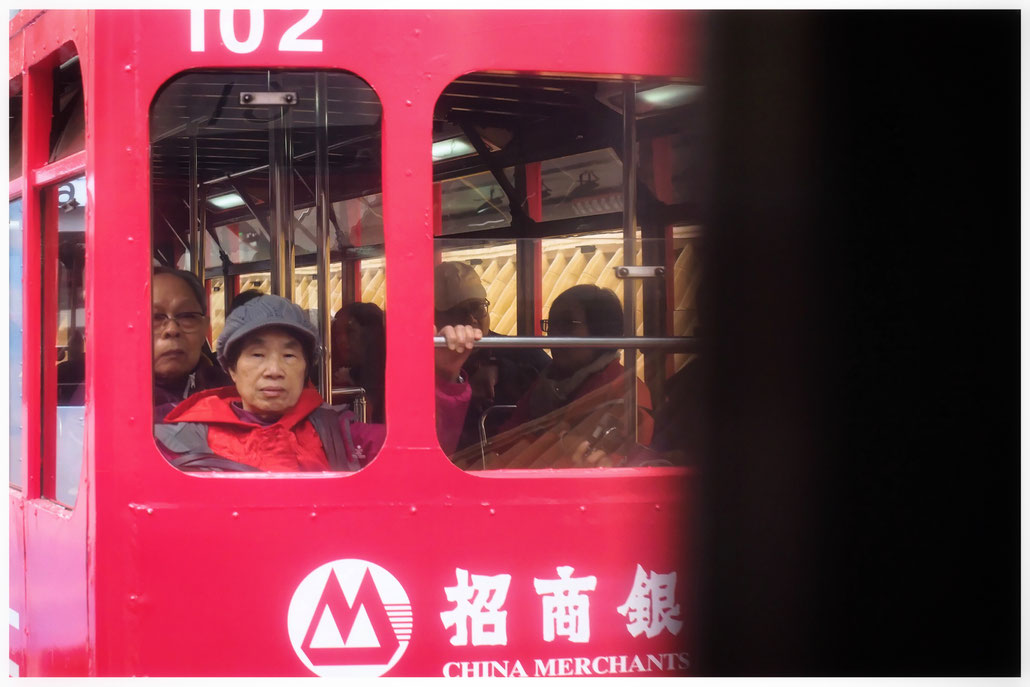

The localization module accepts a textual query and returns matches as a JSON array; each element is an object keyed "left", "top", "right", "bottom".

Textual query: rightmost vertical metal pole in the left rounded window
[{"left": 315, "top": 72, "right": 333, "bottom": 403}]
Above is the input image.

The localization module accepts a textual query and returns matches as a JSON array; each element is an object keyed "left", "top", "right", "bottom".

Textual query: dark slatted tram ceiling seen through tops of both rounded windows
[{"left": 151, "top": 72, "right": 682, "bottom": 188}]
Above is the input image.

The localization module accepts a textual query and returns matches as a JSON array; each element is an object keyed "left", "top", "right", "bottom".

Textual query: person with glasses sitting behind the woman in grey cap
[{"left": 151, "top": 267, "right": 232, "bottom": 411}]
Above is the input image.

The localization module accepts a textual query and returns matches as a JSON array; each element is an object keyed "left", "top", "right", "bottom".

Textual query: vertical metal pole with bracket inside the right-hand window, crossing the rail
[{"left": 622, "top": 81, "right": 638, "bottom": 441}]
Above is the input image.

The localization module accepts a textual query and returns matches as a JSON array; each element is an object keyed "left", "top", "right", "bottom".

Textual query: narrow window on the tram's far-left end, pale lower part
[{"left": 42, "top": 176, "right": 87, "bottom": 506}]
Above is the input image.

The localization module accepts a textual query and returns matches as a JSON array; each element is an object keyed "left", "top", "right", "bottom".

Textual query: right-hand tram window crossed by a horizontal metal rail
[{"left": 433, "top": 73, "right": 700, "bottom": 470}]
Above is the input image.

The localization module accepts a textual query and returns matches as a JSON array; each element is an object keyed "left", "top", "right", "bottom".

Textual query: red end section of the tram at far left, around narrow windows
[{"left": 8, "top": 10, "right": 97, "bottom": 676}]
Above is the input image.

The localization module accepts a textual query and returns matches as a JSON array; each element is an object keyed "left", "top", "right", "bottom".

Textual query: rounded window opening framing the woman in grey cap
[{"left": 150, "top": 70, "right": 385, "bottom": 472}]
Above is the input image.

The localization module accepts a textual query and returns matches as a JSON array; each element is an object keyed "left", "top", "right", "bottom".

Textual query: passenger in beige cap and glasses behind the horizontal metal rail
[{"left": 434, "top": 262, "right": 551, "bottom": 449}]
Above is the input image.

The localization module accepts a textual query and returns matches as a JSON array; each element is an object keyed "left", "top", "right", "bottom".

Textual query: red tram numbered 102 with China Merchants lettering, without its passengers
[{"left": 9, "top": 9, "right": 700, "bottom": 678}]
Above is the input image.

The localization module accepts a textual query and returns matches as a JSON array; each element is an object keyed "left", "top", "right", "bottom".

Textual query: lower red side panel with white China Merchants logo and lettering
[{"left": 118, "top": 467, "right": 694, "bottom": 678}]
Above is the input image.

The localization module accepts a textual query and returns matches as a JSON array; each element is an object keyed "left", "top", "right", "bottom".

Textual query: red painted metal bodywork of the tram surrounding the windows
[{"left": 11, "top": 10, "right": 698, "bottom": 677}]
